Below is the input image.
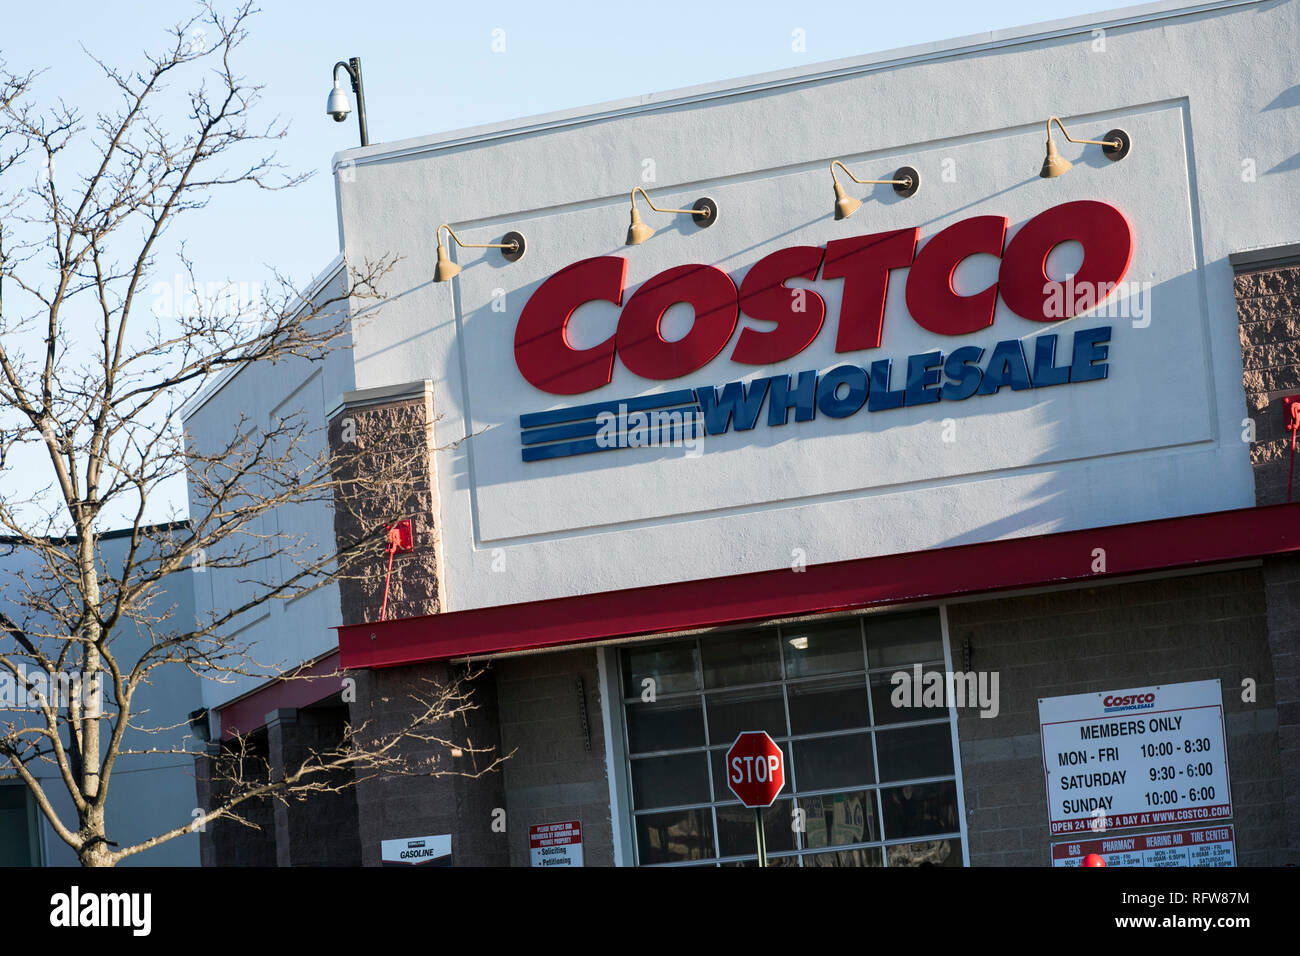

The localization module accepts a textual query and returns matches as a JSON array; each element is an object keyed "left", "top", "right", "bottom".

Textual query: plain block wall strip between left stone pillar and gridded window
[{"left": 495, "top": 649, "right": 614, "bottom": 866}]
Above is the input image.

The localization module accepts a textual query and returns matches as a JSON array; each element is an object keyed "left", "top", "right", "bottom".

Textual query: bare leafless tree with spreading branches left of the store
[{"left": 0, "top": 4, "right": 502, "bottom": 866}]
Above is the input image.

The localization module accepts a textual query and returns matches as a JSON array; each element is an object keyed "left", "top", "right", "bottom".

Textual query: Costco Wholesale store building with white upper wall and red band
[{"left": 189, "top": 1, "right": 1300, "bottom": 866}]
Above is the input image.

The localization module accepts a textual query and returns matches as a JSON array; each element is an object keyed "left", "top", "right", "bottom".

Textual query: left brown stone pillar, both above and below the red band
[{"left": 329, "top": 382, "right": 508, "bottom": 866}]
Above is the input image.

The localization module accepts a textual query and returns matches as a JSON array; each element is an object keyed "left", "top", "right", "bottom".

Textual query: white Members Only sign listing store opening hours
[{"left": 1039, "top": 680, "right": 1232, "bottom": 835}]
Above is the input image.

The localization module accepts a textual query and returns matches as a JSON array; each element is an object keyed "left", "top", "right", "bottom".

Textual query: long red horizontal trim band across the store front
[{"left": 335, "top": 503, "right": 1300, "bottom": 669}]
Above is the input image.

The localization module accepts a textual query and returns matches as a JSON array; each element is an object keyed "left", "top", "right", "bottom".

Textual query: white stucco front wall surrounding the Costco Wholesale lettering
[{"left": 327, "top": 1, "right": 1300, "bottom": 610}]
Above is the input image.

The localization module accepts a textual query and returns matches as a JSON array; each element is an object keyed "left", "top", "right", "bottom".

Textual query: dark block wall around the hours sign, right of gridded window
[{"left": 948, "top": 568, "right": 1295, "bottom": 866}]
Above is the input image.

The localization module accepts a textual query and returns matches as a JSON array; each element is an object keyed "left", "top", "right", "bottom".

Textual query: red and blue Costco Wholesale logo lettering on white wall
[{"left": 515, "top": 200, "right": 1134, "bottom": 462}]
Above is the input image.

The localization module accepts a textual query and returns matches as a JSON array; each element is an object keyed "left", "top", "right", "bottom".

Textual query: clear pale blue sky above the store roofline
[{"left": 0, "top": 0, "right": 1133, "bottom": 530}]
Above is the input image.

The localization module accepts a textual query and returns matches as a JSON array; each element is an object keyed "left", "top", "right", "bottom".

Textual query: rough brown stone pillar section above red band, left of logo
[{"left": 329, "top": 388, "right": 441, "bottom": 624}]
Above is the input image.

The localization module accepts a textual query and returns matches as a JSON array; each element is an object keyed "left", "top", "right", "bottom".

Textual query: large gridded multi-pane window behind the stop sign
[{"left": 616, "top": 610, "right": 962, "bottom": 866}]
